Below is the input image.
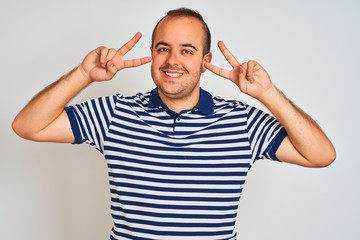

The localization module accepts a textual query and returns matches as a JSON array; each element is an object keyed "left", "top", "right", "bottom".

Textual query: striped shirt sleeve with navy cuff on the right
[{"left": 247, "top": 106, "right": 287, "bottom": 162}]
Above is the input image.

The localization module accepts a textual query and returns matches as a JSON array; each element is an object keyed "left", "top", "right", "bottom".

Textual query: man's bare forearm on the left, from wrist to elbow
[{"left": 13, "top": 67, "right": 90, "bottom": 140}]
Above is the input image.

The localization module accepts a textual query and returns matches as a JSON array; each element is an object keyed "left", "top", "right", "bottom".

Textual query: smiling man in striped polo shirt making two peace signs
[{"left": 13, "top": 9, "right": 335, "bottom": 239}]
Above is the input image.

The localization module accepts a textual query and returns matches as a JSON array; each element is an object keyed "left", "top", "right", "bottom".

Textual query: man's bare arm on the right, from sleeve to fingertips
[{"left": 205, "top": 42, "right": 336, "bottom": 167}]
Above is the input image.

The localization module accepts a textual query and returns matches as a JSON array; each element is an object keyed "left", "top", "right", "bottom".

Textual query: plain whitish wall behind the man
[{"left": 0, "top": 0, "right": 360, "bottom": 240}]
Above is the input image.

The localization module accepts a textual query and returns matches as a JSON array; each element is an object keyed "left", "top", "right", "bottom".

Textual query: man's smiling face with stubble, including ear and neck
[{"left": 151, "top": 17, "right": 211, "bottom": 101}]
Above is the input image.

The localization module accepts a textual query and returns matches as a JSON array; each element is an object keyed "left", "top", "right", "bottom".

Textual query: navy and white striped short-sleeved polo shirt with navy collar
[{"left": 66, "top": 89, "right": 286, "bottom": 240}]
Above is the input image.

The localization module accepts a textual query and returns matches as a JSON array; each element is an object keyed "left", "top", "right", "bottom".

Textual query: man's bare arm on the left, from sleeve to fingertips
[{"left": 12, "top": 33, "right": 151, "bottom": 143}]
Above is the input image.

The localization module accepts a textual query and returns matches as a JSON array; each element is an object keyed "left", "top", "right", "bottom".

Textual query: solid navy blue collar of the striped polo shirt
[{"left": 149, "top": 88, "right": 214, "bottom": 115}]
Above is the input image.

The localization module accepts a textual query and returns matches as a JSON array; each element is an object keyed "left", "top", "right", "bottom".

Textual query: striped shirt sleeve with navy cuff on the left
[{"left": 65, "top": 96, "right": 115, "bottom": 153}]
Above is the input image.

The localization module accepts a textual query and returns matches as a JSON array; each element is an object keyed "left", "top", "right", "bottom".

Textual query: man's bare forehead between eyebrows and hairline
[{"left": 154, "top": 16, "right": 205, "bottom": 46}]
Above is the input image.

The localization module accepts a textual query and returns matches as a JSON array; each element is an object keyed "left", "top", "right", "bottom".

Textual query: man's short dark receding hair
[{"left": 151, "top": 8, "right": 211, "bottom": 55}]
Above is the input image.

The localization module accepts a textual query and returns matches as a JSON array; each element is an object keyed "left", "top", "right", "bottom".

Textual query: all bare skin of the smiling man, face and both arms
[{"left": 13, "top": 17, "right": 336, "bottom": 167}]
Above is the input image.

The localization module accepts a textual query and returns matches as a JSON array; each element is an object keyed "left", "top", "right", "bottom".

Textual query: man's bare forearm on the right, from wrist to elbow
[{"left": 260, "top": 86, "right": 336, "bottom": 166}]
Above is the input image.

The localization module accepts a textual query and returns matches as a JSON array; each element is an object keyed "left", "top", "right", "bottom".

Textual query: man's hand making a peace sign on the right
[{"left": 205, "top": 41, "right": 273, "bottom": 100}]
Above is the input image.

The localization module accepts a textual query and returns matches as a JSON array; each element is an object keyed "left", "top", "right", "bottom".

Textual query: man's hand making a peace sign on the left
[{"left": 79, "top": 32, "right": 151, "bottom": 82}]
